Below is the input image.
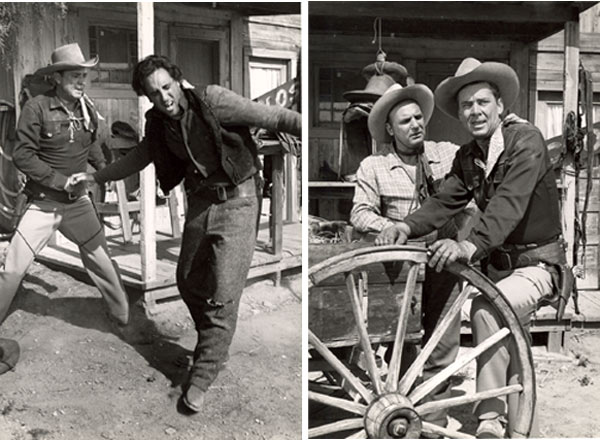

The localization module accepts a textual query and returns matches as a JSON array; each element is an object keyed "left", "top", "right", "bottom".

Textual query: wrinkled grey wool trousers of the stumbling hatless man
[{"left": 177, "top": 196, "right": 258, "bottom": 390}]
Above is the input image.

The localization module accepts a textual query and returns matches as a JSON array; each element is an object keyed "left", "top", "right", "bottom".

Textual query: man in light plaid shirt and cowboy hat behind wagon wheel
[{"left": 350, "top": 83, "right": 460, "bottom": 432}]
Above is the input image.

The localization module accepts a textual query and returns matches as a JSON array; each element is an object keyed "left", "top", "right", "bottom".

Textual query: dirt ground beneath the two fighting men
[{"left": 0, "top": 244, "right": 302, "bottom": 440}]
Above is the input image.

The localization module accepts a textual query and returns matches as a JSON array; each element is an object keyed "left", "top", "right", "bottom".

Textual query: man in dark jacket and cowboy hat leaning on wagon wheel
[{"left": 378, "top": 58, "right": 565, "bottom": 438}]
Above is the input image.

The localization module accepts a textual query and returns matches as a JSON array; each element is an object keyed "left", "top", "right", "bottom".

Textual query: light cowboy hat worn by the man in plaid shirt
[{"left": 368, "top": 84, "right": 434, "bottom": 143}]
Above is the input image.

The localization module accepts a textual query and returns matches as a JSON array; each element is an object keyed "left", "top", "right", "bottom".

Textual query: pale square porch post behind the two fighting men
[{"left": 137, "top": 2, "right": 156, "bottom": 284}]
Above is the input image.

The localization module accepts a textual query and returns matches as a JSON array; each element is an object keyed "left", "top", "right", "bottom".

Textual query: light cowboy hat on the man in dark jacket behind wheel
[{"left": 435, "top": 58, "right": 519, "bottom": 119}]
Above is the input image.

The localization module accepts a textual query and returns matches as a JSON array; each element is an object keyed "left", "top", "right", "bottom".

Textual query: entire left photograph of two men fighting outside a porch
[{"left": 0, "top": 2, "right": 304, "bottom": 440}]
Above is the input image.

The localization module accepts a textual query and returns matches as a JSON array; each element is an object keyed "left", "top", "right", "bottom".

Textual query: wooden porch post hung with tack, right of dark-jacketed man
[{"left": 562, "top": 20, "right": 579, "bottom": 265}]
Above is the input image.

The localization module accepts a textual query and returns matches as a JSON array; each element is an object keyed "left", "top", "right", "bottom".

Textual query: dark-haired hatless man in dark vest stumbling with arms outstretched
[{"left": 77, "top": 55, "right": 301, "bottom": 412}]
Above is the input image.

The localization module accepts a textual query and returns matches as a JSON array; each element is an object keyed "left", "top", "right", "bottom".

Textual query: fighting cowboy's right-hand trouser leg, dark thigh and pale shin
[{"left": 58, "top": 196, "right": 129, "bottom": 325}]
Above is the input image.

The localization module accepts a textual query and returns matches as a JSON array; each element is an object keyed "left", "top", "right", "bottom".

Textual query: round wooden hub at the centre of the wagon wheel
[{"left": 364, "top": 393, "right": 422, "bottom": 438}]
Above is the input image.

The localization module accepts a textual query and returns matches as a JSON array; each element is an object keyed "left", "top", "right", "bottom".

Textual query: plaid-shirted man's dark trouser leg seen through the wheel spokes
[{"left": 422, "top": 267, "right": 460, "bottom": 426}]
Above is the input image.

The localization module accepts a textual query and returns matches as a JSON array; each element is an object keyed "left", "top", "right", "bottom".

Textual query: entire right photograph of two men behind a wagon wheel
[{"left": 306, "top": 2, "right": 600, "bottom": 439}]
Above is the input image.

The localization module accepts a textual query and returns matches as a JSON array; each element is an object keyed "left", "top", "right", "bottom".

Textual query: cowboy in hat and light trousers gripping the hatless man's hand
[{"left": 0, "top": 43, "right": 129, "bottom": 332}]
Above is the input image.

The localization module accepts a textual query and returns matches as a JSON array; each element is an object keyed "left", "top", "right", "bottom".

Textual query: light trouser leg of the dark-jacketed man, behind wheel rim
[{"left": 471, "top": 267, "right": 552, "bottom": 430}]
